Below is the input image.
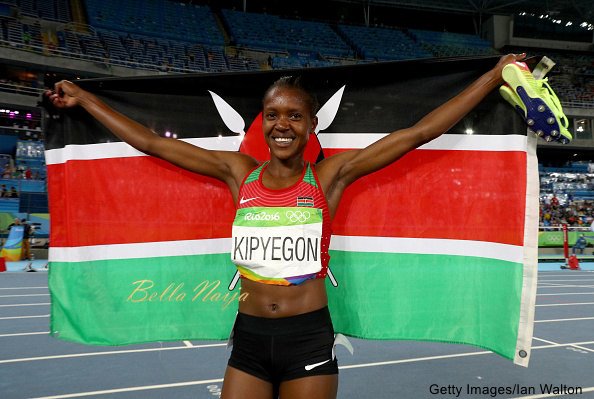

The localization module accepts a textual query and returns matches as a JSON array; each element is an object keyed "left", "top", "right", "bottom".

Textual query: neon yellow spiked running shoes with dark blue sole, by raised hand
[{"left": 499, "top": 62, "right": 573, "bottom": 144}]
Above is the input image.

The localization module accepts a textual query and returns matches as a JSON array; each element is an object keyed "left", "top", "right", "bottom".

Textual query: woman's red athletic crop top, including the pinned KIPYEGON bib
[{"left": 231, "top": 162, "right": 331, "bottom": 285}]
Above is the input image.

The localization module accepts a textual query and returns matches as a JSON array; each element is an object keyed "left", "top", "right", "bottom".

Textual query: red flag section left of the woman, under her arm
[{"left": 48, "top": 157, "right": 235, "bottom": 247}]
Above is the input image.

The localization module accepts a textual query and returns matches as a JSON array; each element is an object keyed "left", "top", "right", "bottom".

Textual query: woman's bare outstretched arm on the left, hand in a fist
[{"left": 46, "top": 80, "right": 256, "bottom": 198}]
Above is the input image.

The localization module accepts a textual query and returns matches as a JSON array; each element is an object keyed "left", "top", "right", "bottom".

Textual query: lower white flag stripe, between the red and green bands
[{"left": 49, "top": 236, "right": 523, "bottom": 264}]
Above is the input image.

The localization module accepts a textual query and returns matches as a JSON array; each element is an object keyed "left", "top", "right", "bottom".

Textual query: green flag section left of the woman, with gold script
[{"left": 49, "top": 254, "right": 240, "bottom": 345}]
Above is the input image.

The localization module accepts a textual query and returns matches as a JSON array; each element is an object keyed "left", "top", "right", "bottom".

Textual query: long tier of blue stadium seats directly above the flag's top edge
[{"left": 0, "top": 0, "right": 520, "bottom": 72}]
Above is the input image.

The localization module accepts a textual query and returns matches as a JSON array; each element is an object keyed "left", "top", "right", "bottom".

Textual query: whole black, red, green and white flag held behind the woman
[{"left": 46, "top": 57, "right": 538, "bottom": 365}]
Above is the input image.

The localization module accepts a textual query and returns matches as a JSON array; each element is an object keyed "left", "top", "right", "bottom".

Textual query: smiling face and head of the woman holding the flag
[{"left": 262, "top": 86, "right": 318, "bottom": 160}]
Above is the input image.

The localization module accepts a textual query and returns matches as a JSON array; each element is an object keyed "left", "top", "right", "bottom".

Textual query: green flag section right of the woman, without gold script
[{"left": 329, "top": 251, "right": 523, "bottom": 359}]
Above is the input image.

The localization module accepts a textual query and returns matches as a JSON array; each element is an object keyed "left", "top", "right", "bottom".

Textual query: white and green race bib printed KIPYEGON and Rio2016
[{"left": 231, "top": 207, "right": 322, "bottom": 278}]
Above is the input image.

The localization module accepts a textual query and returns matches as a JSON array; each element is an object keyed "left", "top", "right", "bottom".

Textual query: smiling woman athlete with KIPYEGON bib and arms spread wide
[{"left": 46, "top": 54, "right": 525, "bottom": 399}]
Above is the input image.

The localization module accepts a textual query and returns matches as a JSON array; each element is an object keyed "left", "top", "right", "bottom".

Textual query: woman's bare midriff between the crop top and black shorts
[{"left": 239, "top": 278, "right": 328, "bottom": 318}]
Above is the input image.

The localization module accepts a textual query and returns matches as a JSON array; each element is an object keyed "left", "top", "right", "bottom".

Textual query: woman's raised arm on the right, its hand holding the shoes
[{"left": 317, "top": 54, "right": 525, "bottom": 214}]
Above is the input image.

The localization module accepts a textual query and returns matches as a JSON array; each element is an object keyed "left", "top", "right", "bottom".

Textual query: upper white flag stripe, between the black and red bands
[{"left": 45, "top": 133, "right": 527, "bottom": 165}]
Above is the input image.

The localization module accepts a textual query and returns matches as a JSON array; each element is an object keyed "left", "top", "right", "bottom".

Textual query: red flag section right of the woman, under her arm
[{"left": 324, "top": 149, "right": 526, "bottom": 245}]
